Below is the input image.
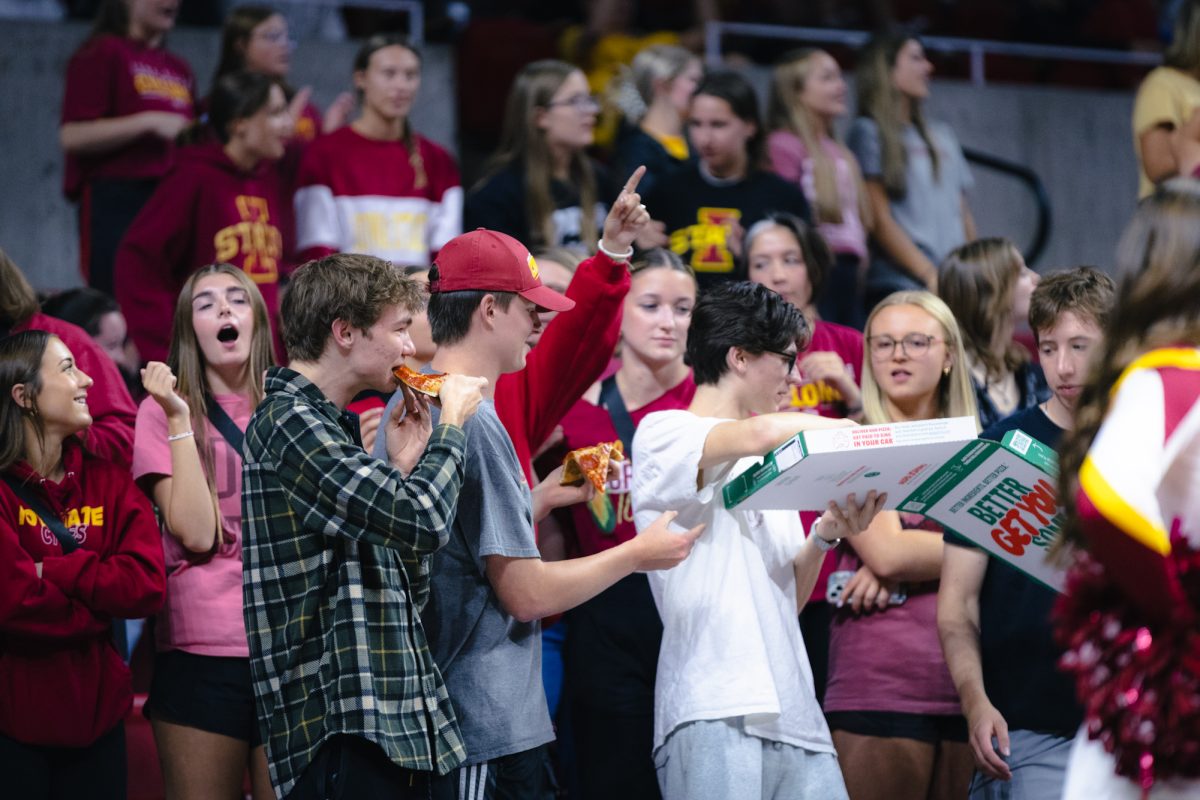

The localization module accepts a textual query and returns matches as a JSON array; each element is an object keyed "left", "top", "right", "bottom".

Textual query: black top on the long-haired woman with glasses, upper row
[{"left": 463, "top": 162, "right": 617, "bottom": 254}]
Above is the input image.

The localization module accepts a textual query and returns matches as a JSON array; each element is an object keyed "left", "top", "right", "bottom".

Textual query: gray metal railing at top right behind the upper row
[{"left": 704, "top": 22, "right": 1163, "bottom": 86}]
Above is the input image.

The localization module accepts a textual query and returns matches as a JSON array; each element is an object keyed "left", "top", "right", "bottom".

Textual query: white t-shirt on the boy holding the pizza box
[{"left": 631, "top": 411, "right": 834, "bottom": 753}]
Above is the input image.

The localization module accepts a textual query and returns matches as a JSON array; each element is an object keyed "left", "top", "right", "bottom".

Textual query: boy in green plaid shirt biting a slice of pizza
[{"left": 241, "top": 254, "right": 486, "bottom": 800}]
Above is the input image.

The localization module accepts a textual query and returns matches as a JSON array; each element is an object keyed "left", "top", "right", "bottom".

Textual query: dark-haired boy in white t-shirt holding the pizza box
[{"left": 631, "top": 283, "right": 883, "bottom": 800}]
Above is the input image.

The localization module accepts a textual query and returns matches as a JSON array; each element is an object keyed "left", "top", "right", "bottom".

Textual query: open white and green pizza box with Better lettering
[{"left": 724, "top": 417, "right": 1064, "bottom": 591}]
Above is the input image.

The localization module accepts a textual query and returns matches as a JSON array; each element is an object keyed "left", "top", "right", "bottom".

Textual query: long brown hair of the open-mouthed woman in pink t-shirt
[{"left": 167, "top": 264, "right": 275, "bottom": 541}]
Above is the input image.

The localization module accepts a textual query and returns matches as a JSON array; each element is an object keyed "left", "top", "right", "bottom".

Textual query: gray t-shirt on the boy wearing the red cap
[{"left": 405, "top": 401, "right": 554, "bottom": 764}]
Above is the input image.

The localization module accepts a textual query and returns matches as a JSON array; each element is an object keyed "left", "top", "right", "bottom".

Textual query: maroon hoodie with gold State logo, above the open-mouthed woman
[{"left": 115, "top": 144, "right": 292, "bottom": 361}]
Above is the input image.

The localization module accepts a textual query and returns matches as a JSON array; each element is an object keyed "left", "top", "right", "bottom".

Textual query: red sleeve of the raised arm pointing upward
[{"left": 496, "top": 254, "right": 629, "bottom": 486}]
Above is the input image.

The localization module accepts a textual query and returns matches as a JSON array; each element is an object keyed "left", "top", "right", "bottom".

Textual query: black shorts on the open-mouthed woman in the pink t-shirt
[{"left": 143, "top": 650, "right": 263, "bottom": 747}]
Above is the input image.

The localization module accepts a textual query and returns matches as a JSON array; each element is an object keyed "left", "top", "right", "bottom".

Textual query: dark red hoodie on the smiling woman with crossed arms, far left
[{"left": 0, "top": 439, "right": 167, "bottom": 747}]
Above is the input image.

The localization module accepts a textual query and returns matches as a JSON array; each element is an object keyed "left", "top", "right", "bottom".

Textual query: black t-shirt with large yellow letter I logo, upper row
[{"left": 642, "top": 163, "right": 810, "bottom": 289}]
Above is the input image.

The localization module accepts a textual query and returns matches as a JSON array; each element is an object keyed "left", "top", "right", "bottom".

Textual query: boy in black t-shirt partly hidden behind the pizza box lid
[{"left": 937, "top": 266, "right": 1115, "bottom": 800}]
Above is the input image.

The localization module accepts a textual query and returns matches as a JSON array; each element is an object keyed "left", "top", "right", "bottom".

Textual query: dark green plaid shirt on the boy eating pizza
[{"left": 241, "top": 367, "right": 467, "bottom": 798}]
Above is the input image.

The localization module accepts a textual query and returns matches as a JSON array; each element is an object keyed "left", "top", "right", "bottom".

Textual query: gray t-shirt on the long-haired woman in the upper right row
[{"left": 846, "top": 116, "right": 974, "bottom": 264}]
